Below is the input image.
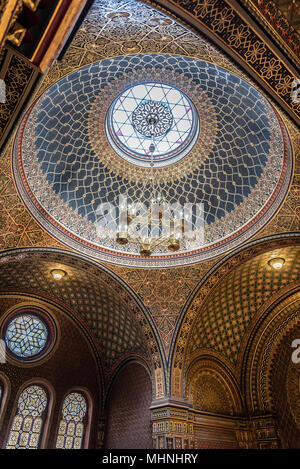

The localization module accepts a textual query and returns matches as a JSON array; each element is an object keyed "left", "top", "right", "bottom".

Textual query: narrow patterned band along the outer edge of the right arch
[{"left": 169, "top": 233, "right": 300, "bottom": 398}]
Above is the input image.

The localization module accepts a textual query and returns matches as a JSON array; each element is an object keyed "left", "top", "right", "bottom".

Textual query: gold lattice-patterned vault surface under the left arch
[{"left": 0, "top": 252, "right": 149, "bottom": 372}]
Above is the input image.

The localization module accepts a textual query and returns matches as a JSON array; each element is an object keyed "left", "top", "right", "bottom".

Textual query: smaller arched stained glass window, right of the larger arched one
[{"left": 56, "top": 392, "right": 87, "bottom": 449}]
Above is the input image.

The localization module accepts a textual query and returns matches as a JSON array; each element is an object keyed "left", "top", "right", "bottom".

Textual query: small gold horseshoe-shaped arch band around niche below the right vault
[{"left": 184, "top": 351, "right": 243, "bottom": 415}]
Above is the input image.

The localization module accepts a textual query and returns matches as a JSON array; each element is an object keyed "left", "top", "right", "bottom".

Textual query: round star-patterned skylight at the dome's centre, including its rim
[{"left": 106, "top": 83, "right": 199, "bottom": 166}]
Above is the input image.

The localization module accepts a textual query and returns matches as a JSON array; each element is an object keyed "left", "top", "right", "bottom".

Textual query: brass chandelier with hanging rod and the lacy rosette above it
[{"left": 116, "top": 106, "right": 190, "bottom": 257}]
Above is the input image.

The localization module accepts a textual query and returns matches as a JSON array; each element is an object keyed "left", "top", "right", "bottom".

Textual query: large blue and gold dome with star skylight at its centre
[{"left": 14, "top": 54, "right": 292, "bottom": 267}]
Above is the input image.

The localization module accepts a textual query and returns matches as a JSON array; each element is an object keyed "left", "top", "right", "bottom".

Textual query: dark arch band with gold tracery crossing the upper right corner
[{"left": 140, "top": 0, "right": 300, "bottom": 125}]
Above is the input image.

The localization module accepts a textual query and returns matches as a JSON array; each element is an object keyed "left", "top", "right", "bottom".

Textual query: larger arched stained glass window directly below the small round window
[{"left": 6, "top": 385, "right": 47, "bottom": 449}]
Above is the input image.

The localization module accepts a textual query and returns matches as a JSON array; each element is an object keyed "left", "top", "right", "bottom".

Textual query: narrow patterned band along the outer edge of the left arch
[{"left": 0, "top": 248, "right": 166, "bottom": 398}]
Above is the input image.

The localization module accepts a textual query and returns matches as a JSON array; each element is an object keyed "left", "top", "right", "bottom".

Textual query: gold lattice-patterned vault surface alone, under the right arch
[{"left": 188, "top": 246, "right": 300, "bottom": 366}]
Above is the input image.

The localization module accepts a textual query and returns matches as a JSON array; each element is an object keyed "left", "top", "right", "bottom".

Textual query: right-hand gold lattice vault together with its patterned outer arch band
[{"left": 172, "top": 234, "right": 300, "bottom": 397}]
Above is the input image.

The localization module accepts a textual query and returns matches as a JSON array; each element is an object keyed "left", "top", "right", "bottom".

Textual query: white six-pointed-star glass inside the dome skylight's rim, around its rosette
[{"left": 109, "top": 83, "right": 194, "bottom": 165}]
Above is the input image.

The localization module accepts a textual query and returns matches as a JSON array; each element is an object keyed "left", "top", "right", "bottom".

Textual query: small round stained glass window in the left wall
[{"left": 5, "top": 314, "right": 48, "bottom": 358}]
